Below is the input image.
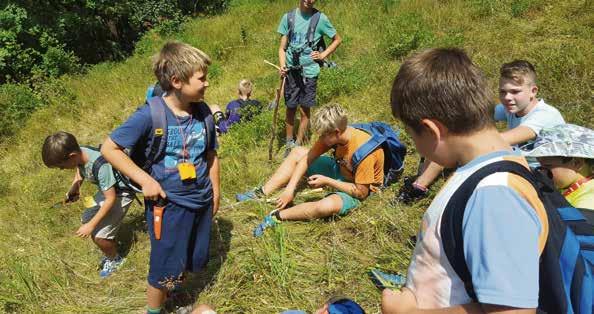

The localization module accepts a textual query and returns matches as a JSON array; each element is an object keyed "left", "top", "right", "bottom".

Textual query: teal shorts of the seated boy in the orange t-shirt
[{"left": 305, "top": 156, "right": 361, "bottom": 216}]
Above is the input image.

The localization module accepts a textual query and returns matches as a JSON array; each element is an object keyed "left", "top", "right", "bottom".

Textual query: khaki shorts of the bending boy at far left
[{"left": 80, "top": 192, "right": 134, "bottom": 240}]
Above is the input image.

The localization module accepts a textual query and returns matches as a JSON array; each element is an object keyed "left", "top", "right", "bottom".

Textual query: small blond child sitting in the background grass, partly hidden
[{"left": 211, "top": 79, "right": 262, "bottom": 134}]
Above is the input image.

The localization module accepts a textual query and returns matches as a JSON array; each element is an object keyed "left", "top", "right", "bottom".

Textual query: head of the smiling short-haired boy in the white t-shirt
[{"left": 499, "top": 60, "right": 538, "bottom": 116}]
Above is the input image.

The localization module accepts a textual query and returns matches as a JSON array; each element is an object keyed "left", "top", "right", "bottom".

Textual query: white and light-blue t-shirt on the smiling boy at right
[{"left": 494, "top": 99, "right": 565, "bottom": 146}]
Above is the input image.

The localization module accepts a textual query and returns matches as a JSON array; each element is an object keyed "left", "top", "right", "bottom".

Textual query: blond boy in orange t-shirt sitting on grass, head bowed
[{"left": 236, "top": 104, "right": 384, "bottom": 237}]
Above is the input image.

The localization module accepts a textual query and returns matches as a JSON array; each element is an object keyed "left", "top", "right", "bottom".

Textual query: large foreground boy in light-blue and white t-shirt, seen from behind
[{"left": 382, "top": 49, "right": 548, "bottom": 313}]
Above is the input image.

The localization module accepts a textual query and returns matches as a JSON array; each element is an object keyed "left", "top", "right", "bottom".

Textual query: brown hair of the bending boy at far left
[{"left": 41, "top": 131, "right": 80, "bottom": 167}]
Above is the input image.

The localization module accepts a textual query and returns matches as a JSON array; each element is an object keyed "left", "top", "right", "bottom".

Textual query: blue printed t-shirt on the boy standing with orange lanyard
[{"left": 110, "top": 98, "right": 216, "bottom": 209}]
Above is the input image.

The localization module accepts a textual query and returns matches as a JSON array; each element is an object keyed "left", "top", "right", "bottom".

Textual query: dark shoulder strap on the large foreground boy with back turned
[{"left": 440, "top": 160, "right": 535, "bottom": 301}]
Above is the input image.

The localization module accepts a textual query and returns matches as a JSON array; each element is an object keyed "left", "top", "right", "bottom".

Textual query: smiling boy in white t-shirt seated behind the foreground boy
[{"left": 397, "top": 60, "right": 565, "bottom": 203}]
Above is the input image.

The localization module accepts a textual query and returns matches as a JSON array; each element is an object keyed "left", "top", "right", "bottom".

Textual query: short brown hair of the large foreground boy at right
[{"left": 391, "top": 48, "right": 494, "bottom": 135}]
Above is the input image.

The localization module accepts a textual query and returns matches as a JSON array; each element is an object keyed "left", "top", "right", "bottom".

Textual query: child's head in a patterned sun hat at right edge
[{"left": 525, "top": 124, "right": 594, "bottom": 189}]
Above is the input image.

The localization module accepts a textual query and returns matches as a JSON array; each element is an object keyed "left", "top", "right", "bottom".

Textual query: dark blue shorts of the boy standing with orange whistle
[{"left": 145, "top": 201, "right": 212, "bottom": 290}]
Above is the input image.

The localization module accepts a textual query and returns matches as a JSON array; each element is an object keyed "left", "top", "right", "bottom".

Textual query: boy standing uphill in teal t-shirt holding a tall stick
[{"left": 277, "top": 0, "right": 342, "bottom": 153}]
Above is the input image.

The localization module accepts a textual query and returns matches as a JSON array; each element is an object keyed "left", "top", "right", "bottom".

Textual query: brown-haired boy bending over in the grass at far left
[{"left": 41, "top": 131, "right": 134, "bottom": 278}]
